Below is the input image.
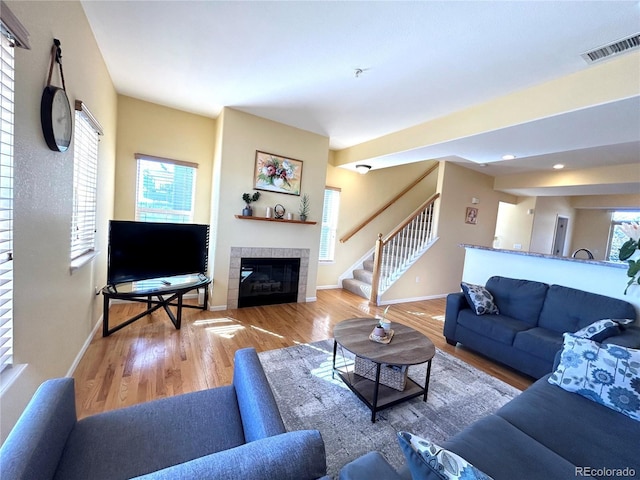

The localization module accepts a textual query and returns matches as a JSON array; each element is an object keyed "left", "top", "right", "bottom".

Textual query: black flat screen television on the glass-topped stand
[{"left": 107, "top": 220, "right": 209, "bottom": 285}]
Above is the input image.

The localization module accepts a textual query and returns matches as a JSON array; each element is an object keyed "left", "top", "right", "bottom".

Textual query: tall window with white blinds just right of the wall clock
[{"left": 71, "top": 101, "right": 102, "bottom": 268}]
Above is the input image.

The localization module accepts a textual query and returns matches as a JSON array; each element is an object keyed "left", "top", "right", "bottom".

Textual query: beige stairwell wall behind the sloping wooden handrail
[{"left": 318, "top": 161, "right": 438, "bottom": 286}]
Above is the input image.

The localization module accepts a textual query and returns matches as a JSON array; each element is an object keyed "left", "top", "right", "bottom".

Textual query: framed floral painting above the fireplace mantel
[{"left": 253, "top": 150, "right": 302, "bottom": 196}]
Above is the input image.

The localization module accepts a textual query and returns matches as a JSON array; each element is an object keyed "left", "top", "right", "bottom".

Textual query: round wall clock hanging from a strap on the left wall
[{"left": 40, "top": 38, "right": 73, "bottom": 152}]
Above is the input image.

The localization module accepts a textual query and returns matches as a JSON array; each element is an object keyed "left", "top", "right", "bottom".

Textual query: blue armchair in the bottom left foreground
[{"left": 0, "top": 349, "right": 326, "bottom": 480}]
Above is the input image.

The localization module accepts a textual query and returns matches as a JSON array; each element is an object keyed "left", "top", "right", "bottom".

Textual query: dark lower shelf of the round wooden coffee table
[{"left": 334, "top": 361, "right": 431, "bottom": 423}]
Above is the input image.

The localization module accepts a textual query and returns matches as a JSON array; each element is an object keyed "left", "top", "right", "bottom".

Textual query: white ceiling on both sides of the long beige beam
[{"left": 82, "top": 0, "right": 640, "bottom": 188}]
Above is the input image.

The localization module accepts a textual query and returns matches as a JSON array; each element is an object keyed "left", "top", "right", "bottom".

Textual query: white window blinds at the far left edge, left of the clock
[{"left": 0, "top": 29, "right": 14, "bottom": 371}]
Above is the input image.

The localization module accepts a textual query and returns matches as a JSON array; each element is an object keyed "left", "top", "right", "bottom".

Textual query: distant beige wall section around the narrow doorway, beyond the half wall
[{"left": 529, "top": 197, "right": 575, "bottom": 256}]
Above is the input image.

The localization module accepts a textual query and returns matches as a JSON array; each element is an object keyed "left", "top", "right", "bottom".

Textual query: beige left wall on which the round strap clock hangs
[{"left": 0, "top": 1, "right": 117, "bottom": 440}]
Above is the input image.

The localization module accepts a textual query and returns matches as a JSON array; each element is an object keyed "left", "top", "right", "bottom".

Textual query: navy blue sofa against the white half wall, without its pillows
[{"left": 444, "top": 276, "right": 640, "bottom": 378}]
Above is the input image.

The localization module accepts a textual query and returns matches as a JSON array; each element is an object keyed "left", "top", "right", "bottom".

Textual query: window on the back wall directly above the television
[{"left": 136, "top": 153, "right": 198, "bottom": 223}]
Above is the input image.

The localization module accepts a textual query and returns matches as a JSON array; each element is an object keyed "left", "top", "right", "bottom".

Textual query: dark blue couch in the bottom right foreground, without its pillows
[{"left": 340, "top": 376, "right": 640, "bottom": 480}]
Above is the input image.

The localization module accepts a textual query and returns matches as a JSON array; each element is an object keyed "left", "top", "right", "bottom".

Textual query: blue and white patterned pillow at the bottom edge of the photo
[{"left": 398, "top": 432, "right": 492, "bottom": 480}]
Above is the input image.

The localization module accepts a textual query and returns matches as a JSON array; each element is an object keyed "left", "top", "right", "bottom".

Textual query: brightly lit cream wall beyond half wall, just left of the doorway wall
[{"left": 493, "top": 197, "right": 536, "bottom": 251}]
